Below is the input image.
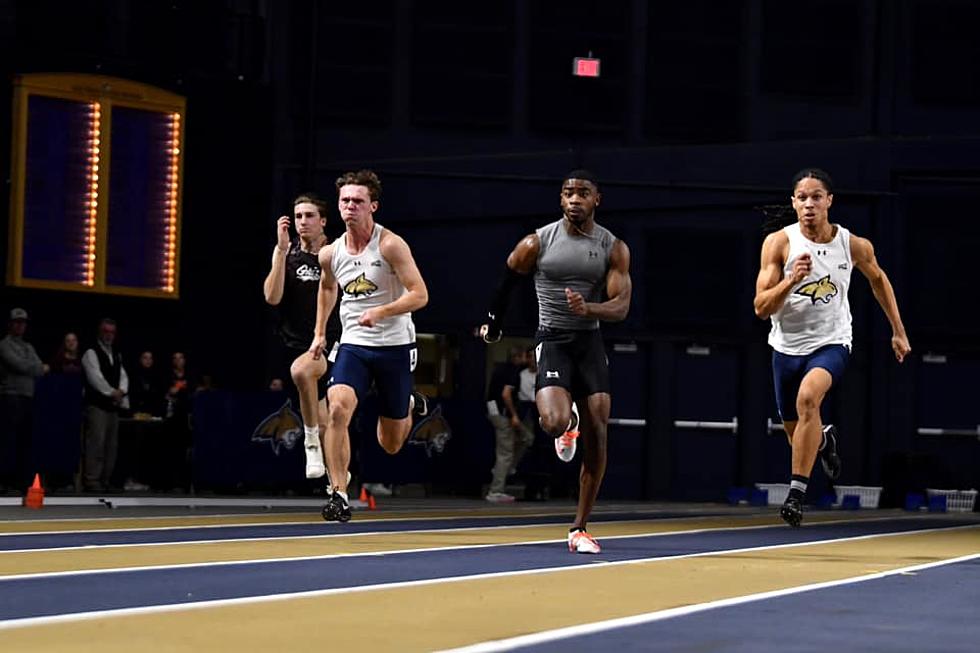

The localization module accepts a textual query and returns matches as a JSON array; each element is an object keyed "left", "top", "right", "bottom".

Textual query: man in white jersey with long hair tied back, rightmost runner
[{"left": 754, "top": 168, "right": 911, "bottom": 527}]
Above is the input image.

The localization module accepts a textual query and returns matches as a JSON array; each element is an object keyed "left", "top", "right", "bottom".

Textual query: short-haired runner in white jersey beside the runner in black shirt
[{"left": 306, "top": 170, "right": 429, "bottom": 522}]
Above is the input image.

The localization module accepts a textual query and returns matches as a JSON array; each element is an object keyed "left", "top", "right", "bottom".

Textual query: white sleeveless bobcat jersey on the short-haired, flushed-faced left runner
[{"left": 330, "top": 223, "right": 415, "bottom": 347}]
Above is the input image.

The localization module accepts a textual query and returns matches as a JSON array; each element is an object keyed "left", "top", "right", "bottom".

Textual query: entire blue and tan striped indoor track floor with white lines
[{"left": 0, "top": 499, "right": 980, "bottom": 653}]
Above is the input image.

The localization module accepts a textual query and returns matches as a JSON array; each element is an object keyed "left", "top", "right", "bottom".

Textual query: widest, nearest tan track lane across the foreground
[{"left": 0, "top": 526, "right": 980, "bottom": 653}]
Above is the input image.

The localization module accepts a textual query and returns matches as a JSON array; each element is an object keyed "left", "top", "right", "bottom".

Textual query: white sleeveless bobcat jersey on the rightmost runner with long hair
[{"left": 769, "top": 223, "right": 853, "bottom": 356}]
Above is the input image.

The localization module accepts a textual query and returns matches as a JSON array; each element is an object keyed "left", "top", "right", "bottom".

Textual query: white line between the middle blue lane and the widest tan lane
[{"left": 0, "top": 524, "right": 980, "bottom": 630}]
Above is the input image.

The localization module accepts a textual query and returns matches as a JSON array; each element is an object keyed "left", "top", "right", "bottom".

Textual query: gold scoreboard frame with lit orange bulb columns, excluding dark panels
[{"left": 7, "top": 73, "right": 187, "bottom": 299}]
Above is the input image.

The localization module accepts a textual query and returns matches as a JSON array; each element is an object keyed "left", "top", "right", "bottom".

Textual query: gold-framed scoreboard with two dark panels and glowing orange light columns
[{"left": 7, "top": 74, "right": 186, "bottom": 298}]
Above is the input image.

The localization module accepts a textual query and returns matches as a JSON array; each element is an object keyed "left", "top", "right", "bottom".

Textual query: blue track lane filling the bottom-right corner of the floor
[{"left": 517, "top": 559, "right": 980, "bottom": 653}]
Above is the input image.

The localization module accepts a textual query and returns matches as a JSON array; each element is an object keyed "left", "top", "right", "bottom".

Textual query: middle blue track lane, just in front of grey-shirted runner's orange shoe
[{"left": 0, "top": 518, "right": 975, "bottom": 620}]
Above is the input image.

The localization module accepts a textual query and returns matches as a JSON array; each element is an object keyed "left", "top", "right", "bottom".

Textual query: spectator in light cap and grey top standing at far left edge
[{"left": 0, "top": 308, "right": 48, "bottom": 493}]
